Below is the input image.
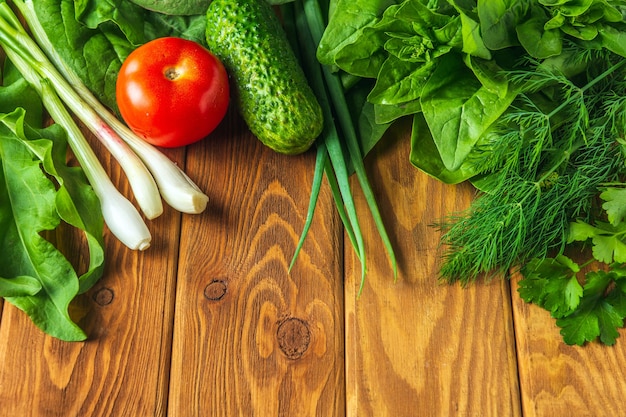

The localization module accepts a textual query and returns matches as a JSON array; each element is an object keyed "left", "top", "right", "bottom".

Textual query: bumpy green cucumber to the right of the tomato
[{"left": 206, "top": 0, "right": 324, "bottom": 155}]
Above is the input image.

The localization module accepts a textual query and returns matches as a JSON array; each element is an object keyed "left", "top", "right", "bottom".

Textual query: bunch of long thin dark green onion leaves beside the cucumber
[{"left": 283, "top": 0, "right": 397, "bottom": 293}]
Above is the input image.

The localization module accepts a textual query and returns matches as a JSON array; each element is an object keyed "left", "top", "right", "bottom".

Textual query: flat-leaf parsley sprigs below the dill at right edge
[{"left": 518, "top": 179, "right": 626, "bottom": 345}]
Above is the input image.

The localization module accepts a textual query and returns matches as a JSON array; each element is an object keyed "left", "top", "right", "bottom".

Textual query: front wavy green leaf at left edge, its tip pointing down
[{"left": 0, "top": 120, "right": 85, "bottom": 340}]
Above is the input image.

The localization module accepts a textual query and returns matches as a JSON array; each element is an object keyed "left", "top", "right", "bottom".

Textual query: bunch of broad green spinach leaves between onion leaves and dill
[{"left": 318, "top": 0, "right": 516, "bottom": 182}]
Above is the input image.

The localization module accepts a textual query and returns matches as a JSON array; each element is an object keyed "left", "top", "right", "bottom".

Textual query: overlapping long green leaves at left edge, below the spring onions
[{"left": 0, "top": 80, "right": 104, "bottom": 340}]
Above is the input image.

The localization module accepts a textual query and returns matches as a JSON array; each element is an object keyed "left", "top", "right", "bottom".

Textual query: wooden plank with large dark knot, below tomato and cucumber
[{"left": 169, "top": 112, "right": 344, "bottom": 417}]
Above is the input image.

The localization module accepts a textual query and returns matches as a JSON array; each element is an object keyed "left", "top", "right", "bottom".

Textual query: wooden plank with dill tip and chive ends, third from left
[{"left": 346, "top": 126, "right": 520, "bottom": 417}]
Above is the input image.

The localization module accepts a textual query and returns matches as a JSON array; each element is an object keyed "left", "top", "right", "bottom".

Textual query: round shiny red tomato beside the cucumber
[{"left": 116, "top": 37, "right": 230, "bottom": 148}]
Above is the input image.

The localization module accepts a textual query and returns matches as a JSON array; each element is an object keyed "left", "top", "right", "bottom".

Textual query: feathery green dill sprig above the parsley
[{"left": 437, "top": 51, "right": 626, "bottom": 283}]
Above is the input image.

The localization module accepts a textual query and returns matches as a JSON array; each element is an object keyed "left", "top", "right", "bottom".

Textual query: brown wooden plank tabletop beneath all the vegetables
[{"left": 0, "top": 111, "right": 626, "bottom": 417}]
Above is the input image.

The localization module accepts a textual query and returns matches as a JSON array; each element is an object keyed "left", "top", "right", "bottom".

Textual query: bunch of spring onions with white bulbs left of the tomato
[{"left": 0, "top": 0, "right": 208, "bottom": 250}]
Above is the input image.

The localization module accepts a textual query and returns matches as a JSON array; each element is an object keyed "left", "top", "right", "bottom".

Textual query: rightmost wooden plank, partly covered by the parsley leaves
[{"left": 512, "top": 275, "right": 626, "bottom": 417}]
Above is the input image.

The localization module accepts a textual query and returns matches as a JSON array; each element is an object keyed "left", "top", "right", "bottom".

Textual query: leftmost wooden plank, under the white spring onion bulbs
[{"left": 0, "top": 132, "right": 184, "bottom": 417}]
